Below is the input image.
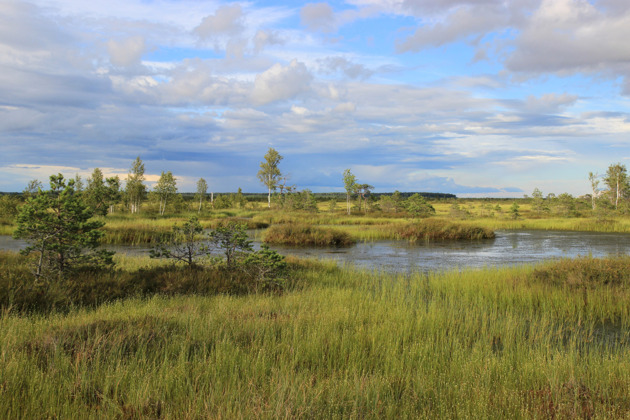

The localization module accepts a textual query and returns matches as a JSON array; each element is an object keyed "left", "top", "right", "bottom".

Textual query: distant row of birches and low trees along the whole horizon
[{"left": 6, "top": 153, "right": 630, "bottom": 218}]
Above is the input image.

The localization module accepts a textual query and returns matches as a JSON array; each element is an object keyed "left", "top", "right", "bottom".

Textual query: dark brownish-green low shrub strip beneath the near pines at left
[{"left": 0, "top": 251, "right": 299, "bottom": 312}]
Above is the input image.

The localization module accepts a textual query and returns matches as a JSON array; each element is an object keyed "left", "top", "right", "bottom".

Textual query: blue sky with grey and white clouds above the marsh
[{"left": 0, "top": 0, "right": 630, "bottom": 197}]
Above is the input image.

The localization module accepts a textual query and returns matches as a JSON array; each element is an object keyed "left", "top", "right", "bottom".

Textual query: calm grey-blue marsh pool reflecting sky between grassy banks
[{"left": 0, "top": 230, "right": 630, "bottom": 272}]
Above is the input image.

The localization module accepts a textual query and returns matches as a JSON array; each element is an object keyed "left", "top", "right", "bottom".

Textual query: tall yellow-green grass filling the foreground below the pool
[{"left": 0, "top": 254, "right": 630, "bottom": 419}]
